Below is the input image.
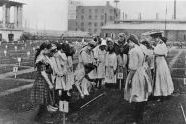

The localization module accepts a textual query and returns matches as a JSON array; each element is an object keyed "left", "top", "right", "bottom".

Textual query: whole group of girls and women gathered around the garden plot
[{"left": 31, "top": 32, "right": 174, "bottom": 124}]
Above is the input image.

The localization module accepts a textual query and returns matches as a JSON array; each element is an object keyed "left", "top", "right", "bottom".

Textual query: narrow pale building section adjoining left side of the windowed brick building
[{"left": 68, "top": 0, "right": 81, "bottom": 31}]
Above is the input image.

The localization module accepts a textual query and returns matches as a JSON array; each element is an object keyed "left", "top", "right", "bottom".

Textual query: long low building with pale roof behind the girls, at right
[{"left": 101, "top": 20, "right": 186, "bottom": 41}]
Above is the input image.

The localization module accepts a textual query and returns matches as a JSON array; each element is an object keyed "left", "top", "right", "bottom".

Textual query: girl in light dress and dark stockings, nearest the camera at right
[{"left": 124, "top": 35, "right": 152, "bottom": 124}]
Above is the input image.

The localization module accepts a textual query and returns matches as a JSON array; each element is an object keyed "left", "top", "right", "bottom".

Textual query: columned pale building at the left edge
[{"left": 0, "top": 0, "right": 23, "bottom": 41}]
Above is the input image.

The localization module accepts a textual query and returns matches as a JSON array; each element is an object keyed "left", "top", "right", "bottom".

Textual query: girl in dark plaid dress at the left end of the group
[{"left": 31, "top": 43, "right": 57, "bottom": 121}]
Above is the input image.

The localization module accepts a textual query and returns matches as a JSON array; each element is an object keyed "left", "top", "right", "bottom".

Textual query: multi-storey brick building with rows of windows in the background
[{"left": 68, "top": 1, "right": 120, "bottom": 35}]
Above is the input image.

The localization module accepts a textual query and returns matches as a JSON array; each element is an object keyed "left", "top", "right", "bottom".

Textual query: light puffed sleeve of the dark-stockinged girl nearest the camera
[{"left": 129, "top": 50, "right": 139, "bottom": 70}]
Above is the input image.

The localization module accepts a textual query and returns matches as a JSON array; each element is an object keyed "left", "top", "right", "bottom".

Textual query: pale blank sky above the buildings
[{"left": 0, "top": 0, "right": 186, "bottom": 31}]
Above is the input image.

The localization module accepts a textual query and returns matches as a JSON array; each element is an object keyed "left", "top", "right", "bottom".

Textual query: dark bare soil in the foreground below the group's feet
[{"left": 0, "top": 89, "right": 186, "bottom": 124}]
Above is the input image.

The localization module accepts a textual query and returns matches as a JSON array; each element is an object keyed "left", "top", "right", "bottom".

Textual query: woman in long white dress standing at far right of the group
[{"left": 153, "top": 37, "right": 174, "bottom": 96}]
